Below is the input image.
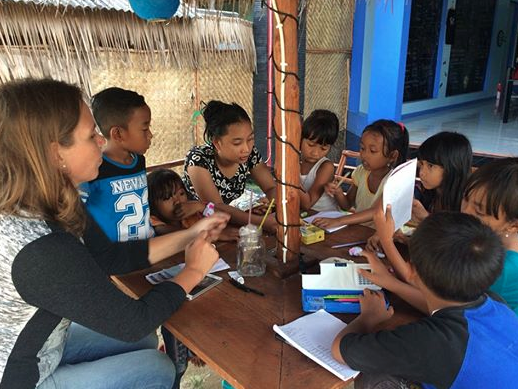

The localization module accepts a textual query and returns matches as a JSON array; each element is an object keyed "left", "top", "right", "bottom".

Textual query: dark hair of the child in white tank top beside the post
[{"left": 302, "top": 109, "right": 340, "bottom": 146}]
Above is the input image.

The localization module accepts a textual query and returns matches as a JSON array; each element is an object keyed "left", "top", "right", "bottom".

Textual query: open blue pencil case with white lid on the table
[{"left": 302, "top": 257, "right": 381, "bottom": 313}]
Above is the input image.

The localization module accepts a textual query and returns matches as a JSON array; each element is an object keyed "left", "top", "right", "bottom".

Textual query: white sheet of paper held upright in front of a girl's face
[{"left": 383, "top": 158, "right": 417, "bottom": 230}]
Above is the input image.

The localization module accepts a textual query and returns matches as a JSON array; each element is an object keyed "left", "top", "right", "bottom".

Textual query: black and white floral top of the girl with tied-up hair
[{"left": 182, "top": 144, "right": 262, "bottom": 204}]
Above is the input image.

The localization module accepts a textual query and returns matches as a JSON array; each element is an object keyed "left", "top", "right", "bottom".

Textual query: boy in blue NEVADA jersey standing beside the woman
[{"left": 81, "top": 88, "right": 153, "bottom": 242}]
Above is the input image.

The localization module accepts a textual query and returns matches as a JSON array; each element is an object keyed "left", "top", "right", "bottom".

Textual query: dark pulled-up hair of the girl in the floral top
[{"left": 203, "top": 100, "right": 251, "bottom": 143}]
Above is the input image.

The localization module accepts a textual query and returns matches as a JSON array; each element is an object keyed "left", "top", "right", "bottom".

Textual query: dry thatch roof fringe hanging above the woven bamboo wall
[{"left": 0, "top": 0, "right": 256, "bottom": 90}]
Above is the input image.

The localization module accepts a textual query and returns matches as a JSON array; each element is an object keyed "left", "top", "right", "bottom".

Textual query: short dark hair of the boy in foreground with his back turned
[{"left": 409, "top": 212, "right": 505, "bottom": 302}]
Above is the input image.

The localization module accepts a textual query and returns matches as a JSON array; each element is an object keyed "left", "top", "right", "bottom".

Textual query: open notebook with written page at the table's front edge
[{"left": 273, "top": 309, "right": 359, "bottom": 381}]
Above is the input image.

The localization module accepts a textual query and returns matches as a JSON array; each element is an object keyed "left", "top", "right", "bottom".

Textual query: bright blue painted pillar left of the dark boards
[{"left": 347, "top": 0, "right": 411, "bottom": 135}]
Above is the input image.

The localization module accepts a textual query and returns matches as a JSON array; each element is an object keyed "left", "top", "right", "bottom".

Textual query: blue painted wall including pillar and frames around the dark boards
[{"left": 347, "top": 0, "right": 513, "bottom": 130}]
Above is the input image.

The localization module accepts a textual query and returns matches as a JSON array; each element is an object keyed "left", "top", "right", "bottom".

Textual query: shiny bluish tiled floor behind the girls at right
[{"left": 404, "top": 102, "right": 518, "bottom": 156}]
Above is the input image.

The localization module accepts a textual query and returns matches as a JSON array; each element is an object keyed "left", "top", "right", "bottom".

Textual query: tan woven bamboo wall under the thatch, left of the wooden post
[{"left": 92, "top": 53, "right": 252, "bottom": 165}]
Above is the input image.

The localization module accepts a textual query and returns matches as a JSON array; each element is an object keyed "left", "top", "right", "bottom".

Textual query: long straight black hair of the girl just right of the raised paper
[{"left": 417, "top": 131, "right": 473, "bottom": 211}]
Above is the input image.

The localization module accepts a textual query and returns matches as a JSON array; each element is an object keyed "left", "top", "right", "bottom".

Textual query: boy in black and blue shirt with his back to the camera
[{"left": 333, "top": 212, "right": 518, "bottom": 389}]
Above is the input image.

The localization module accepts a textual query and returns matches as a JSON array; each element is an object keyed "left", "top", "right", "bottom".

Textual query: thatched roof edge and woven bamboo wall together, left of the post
[{"left": 0, "top": 1, "right": 255, "bottom": 164}]
